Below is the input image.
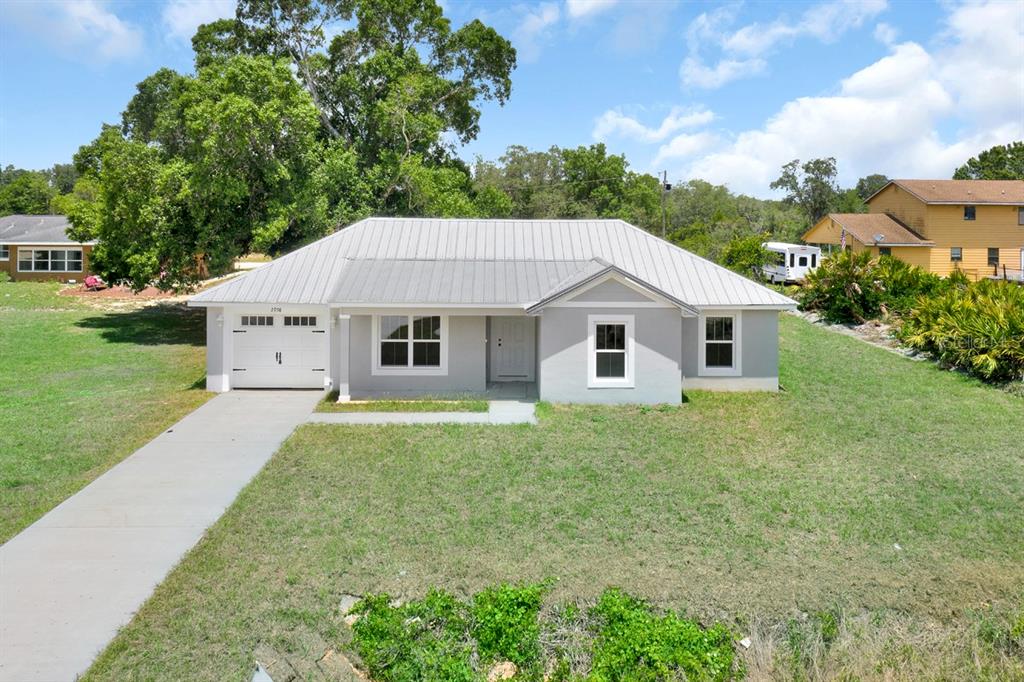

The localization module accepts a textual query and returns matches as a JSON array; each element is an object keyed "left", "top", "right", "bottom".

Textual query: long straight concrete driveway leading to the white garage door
[{"left": 0, "top": 391, "right": 322, "bottom": 682}]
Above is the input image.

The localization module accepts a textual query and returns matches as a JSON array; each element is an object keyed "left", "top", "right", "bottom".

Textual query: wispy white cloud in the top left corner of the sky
[{"left": 4, "top": 0, "right": 142, "bottom": 61}]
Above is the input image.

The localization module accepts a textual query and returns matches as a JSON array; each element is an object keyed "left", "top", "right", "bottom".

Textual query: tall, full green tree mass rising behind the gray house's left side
[{"left": 62, "top": 0, "right": 515, "bottom": 289}]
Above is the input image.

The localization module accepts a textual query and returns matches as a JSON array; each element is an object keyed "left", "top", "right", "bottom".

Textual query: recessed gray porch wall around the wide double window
[{"left": 349, "top": 315, "right": 487, "bottom": 393}]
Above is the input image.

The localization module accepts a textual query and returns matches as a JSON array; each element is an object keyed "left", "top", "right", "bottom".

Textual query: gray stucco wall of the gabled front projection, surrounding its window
[{"left": 538, "top": 307, "right": 682, "bottom": 403}]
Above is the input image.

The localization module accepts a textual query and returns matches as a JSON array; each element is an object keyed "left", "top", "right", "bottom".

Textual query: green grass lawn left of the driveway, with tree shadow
[{"left": 0, "top": 282, "right": 209, "bottom": 543}]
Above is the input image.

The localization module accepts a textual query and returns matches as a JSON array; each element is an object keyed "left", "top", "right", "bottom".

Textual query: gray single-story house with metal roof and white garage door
[{"left": 188, "top": 218, "right": 795, "bottom": 402}]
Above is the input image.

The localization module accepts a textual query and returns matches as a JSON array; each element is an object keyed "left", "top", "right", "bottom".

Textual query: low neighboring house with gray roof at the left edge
[{"left": 0, "top": 215, "right": 95, "bottom": 283}]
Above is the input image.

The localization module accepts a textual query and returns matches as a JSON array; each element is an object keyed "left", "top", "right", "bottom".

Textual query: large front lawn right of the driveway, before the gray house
[{"left": 87, "top": 316, "right": 1024, "bottom": 680}]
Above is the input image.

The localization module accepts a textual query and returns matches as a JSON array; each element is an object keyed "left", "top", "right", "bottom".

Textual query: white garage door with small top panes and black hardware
[{"left": 231, "top": 314, "right": 328, "bottom": 388}]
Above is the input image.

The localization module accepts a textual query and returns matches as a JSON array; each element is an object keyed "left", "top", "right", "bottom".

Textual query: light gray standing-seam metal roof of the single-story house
[{"left": 191, "top": 218, "right": 795, "bottom": 307}]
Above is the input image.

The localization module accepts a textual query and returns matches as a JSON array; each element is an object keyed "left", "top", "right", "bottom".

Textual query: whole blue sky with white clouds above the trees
[{"left": 0, "top": 0, "right": 1024, "bottom": 197}]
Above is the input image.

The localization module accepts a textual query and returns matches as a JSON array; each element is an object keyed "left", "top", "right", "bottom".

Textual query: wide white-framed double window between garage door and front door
[{"left": 374, "top": 315, "right": 446, "bottom": 374}]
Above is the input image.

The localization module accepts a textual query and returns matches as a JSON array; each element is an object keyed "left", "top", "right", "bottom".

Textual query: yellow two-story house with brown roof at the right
[{"left": 804, "top": 180, "right": 1024, "bottom": 279}]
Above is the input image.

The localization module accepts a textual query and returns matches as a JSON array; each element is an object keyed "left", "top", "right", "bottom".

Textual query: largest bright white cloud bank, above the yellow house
[{"left": 660, "top": 0, "right": 1024, "bottom": 196}]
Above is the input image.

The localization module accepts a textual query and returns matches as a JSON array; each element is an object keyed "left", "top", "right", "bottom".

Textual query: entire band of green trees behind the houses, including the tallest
[{"left": 0, "top": 0, "right": 1024, "bottom": 289}]
